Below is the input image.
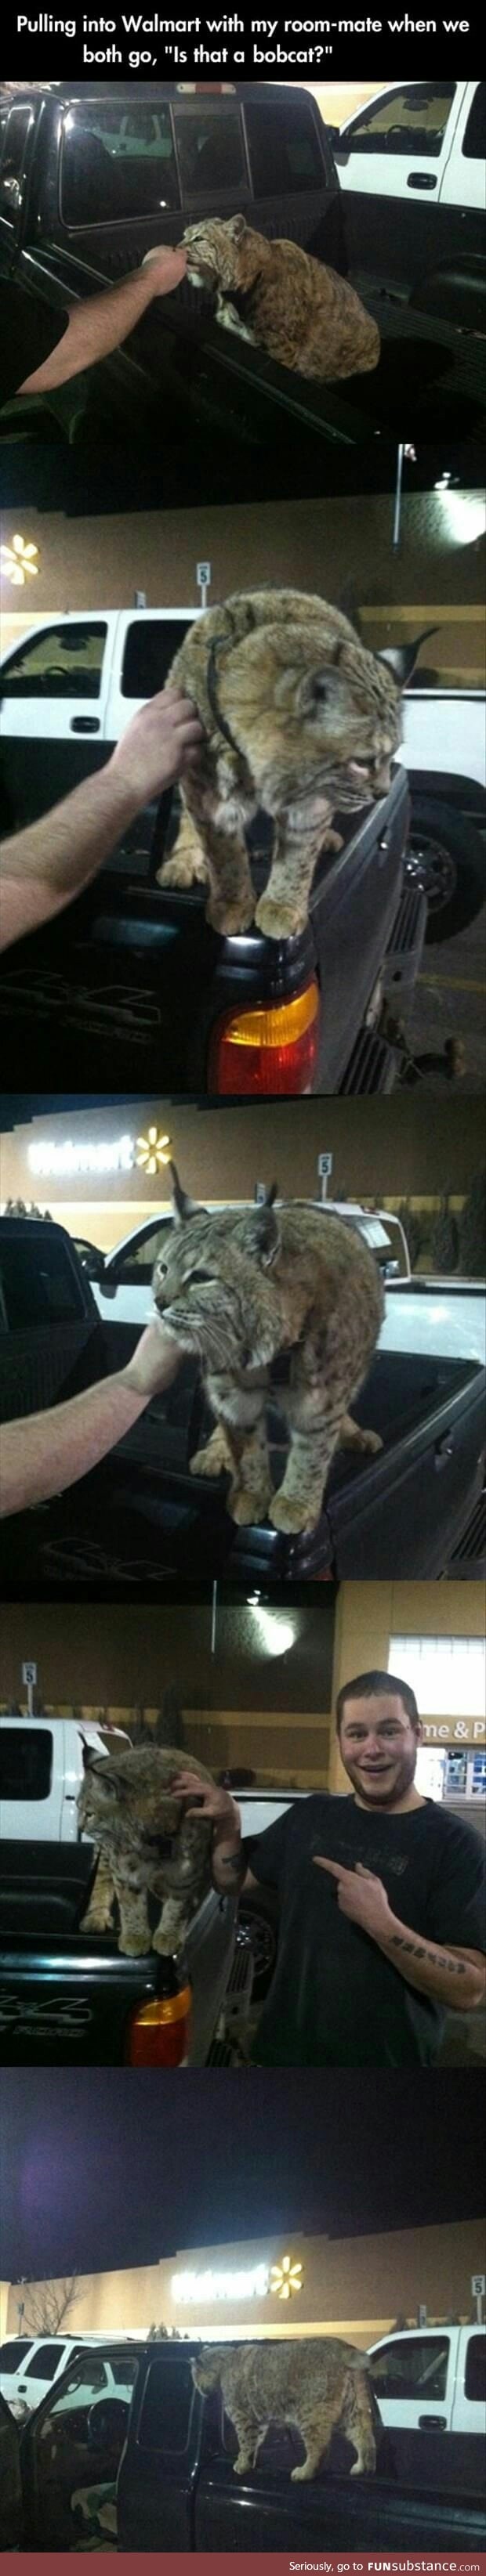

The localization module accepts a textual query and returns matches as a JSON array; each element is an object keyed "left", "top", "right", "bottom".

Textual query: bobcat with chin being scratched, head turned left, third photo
[{"left": 152, "top": 1165, "right": 383, "bottom": 1530}]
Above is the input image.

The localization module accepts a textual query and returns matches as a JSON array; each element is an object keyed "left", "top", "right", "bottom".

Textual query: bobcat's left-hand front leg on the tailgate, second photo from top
[{"left": 185, "top": 770, "right": 255, "bottom": 938}]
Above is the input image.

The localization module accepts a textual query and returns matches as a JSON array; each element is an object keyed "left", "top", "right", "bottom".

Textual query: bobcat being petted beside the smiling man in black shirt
[{"left": 77, "top": 1744, "right": 213, "bottom": 1958}]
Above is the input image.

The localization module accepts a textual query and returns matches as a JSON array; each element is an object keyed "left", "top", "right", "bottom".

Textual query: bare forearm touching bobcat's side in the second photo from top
[{"left": 0, "top": 760, "right": 139, "bottom": 948}]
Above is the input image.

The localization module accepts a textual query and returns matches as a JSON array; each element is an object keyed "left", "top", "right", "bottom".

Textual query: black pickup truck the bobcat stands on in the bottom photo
[{"left": 13, "top": 2342, "right": 484, "bottom": 2560}]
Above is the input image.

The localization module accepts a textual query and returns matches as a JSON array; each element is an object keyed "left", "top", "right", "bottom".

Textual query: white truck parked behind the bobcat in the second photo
[{"left": 0, "top": 608, "right": 486, "bottom": 938}]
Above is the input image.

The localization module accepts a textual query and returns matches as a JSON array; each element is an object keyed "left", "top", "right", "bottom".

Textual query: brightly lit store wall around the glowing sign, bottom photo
[{"left": 8, "top": 2220, "right": 484, "bottom": 2344}]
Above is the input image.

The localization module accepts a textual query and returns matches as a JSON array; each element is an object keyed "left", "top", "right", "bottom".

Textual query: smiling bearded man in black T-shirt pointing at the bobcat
[{"left": 176, "top": 1672, "right": 486, "bottom": 2066}]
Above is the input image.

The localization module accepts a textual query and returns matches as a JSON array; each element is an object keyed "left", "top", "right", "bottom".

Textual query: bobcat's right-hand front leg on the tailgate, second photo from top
[{"left": 255, "top": 801, "right": 332, "bottom": 940}]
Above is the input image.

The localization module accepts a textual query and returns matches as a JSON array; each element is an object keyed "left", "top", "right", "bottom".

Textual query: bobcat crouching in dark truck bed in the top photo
[{"left": 183, "top": 214, "right": 381, "bottom": 381}]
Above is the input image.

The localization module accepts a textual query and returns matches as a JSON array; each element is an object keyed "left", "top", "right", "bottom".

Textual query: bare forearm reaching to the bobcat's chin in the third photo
[{"left": 0, "top": 1371, "right": 149, "bottom": 1517}]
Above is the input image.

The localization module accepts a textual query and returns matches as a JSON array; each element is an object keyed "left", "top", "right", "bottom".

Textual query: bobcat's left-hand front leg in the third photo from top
[{"left": 209, "top": 1375, "right": 273, "bottom": 1527}]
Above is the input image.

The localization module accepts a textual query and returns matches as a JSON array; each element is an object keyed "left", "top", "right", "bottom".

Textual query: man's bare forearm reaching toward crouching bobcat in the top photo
[{"left": 20, "top": 268, "right": 154, "bottom": 394}]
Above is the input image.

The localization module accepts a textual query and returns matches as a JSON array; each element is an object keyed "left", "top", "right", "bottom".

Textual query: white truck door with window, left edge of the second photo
[{"left": 0, "top": 618, "right": 113, "bottom": 829}]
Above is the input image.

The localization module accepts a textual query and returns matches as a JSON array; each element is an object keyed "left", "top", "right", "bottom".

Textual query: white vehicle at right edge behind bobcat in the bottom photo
[{"left": 368, "top": 2326, "right": 486, "bottom": 2437}]
